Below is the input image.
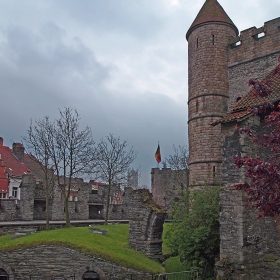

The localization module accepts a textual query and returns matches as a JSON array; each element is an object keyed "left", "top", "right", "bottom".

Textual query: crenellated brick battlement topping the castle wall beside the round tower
[{"left": 228, "top": 17, "right": 280, "bottom": 66}]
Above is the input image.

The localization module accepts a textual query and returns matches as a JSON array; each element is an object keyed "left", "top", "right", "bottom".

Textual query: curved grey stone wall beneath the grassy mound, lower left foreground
[{"left": 0, "top": 245, "right": 156, "bottom": 280}]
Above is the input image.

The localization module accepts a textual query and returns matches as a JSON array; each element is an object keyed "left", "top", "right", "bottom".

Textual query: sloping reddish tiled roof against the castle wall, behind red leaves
[{"left": 211, "top": 66, "right": 280, "bottom": 126}]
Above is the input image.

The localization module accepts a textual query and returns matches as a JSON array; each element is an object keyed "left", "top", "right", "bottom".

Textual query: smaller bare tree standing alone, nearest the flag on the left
[{"left": 95, "top": 134, "right": 137, "bottom": 224}]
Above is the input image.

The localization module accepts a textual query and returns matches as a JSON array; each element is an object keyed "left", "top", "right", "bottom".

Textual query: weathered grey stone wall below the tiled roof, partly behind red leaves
[{"left": 217, "top": 117, "right": 280, "bottom": 280}]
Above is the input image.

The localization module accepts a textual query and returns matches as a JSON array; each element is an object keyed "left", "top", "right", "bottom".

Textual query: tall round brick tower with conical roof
[{"left": 186, "top": 0, "right": 238, "bottom": 186}]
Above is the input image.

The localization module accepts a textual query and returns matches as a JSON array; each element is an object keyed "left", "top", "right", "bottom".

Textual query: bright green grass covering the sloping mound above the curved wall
[{"left": 0, "top": 224, "right": 164, "bottom": 273}]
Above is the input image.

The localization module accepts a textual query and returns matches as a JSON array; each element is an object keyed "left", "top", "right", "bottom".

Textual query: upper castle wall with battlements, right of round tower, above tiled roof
[{"left": 228, "top": 18, "right": 280, "bottom": 109}]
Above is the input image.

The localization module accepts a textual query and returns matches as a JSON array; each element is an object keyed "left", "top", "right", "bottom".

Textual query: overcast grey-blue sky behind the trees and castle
[{"left": 0, "top": 0, "right": 280, "bottom": 185}]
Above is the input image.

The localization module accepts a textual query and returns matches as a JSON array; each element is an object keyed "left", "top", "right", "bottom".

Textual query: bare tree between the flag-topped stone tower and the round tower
[{"left": 164, "top": 145, "right": 189, "bottom": 189}]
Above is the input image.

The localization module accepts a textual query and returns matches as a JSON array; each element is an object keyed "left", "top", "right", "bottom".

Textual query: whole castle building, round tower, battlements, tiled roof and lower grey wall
[{"left": 186, "top": 0, "right": 280, "bottom": 279}]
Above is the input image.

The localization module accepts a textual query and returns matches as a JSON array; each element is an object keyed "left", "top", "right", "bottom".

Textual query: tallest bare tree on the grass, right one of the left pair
[{"left": 50, "top": 107, "right": 95, "bottom": 227}]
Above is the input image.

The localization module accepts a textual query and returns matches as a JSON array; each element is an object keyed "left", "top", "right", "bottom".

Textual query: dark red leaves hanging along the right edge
[{"left": 233, "top": 56, "right": 280, "bottom": 218}]
